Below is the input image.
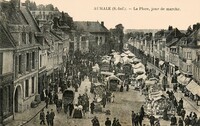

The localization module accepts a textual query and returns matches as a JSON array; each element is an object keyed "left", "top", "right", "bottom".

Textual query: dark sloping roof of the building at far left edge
[{"left": 0, "top": 22, "right": 14, "bottom": 49}]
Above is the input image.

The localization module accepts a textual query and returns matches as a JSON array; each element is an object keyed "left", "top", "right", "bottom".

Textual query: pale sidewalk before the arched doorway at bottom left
[{"left": 7, "top": 101, "right": 45, "bottom": 126}]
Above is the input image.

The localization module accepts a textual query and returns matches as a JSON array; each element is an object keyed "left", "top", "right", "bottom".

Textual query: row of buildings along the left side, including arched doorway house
[{"left": 0, "top": 0, "right": 109, "bottom": 124}]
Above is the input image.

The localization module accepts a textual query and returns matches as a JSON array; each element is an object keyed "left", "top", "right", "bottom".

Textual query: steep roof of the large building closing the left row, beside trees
[{"left": 74, "top": 21, "right": 109, "bottom": 33}]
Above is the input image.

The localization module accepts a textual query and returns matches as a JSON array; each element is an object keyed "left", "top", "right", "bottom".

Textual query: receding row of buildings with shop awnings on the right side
[{"left": 129, "top": 23, "right": 200, "bottom": 103}]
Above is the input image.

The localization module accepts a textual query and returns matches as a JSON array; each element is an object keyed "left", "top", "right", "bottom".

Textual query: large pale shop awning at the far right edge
[{"left": 186, "top": 80, "right": 200, "bottom": 96}]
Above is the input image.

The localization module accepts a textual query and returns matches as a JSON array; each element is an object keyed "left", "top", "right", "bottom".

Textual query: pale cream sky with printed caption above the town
[{"left": 21, "top": 0, "right": 200, "bottom": 30}]
